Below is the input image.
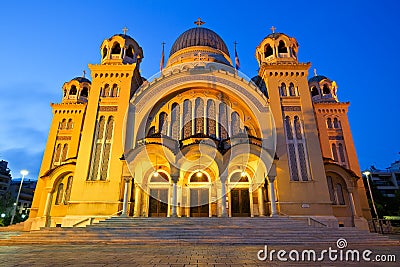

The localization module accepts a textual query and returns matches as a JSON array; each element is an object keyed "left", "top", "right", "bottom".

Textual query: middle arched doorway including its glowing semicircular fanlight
[{"left": 189, "top": 171, "right": 210, "bottom": 217}]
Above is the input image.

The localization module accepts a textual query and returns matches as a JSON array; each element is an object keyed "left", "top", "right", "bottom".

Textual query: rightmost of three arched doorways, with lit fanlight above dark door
[{"left": 229, "top": 172, "right": 251, "bottom": 217}]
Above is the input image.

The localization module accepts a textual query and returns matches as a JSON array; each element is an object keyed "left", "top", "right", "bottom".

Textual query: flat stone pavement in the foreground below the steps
[{"left": 0, "top": 244, "right": 400, "bottom": 267}]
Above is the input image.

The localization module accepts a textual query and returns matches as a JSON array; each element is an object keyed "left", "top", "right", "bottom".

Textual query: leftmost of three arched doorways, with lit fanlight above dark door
[{"left": 148, "top": 171, "right": 169, "bottom": 217}]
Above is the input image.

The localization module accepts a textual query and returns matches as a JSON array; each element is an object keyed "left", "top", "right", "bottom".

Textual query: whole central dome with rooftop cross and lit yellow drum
[{"left": 167, "top": 19, "right": 232, "bottom": 67}]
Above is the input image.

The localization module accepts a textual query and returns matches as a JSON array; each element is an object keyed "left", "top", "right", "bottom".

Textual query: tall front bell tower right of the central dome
[{"left": 255, "top": 27, "right": 332, "bottom": 216}]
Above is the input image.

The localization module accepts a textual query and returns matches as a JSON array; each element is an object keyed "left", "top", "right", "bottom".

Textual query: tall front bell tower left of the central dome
[{"left": 70, "top": 28, "right": 143, "bottom": 217}]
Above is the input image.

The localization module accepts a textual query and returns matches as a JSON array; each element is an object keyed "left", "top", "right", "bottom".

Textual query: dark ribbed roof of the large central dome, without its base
[{"left": 169, "top": 27, "right": 229, "bottom": 57}]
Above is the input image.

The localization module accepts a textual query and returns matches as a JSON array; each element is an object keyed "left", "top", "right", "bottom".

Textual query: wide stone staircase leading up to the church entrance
[{"left": 0, "top": 217, "right": 400, "bottom": 247}]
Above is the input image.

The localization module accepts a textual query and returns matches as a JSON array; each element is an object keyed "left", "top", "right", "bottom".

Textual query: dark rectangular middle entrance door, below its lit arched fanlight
[{"left": 190, "top": 188, "right": 209, "bottom": 217}]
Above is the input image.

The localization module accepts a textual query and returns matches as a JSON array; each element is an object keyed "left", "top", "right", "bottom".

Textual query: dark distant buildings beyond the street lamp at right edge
[{"left": 363, "top": 160, "right": 400, "bottom": 197}]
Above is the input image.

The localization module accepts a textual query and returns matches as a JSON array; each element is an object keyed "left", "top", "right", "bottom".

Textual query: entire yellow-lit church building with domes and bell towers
[{"left": 26, "top": 20, "right": 371, "bottom": 230}]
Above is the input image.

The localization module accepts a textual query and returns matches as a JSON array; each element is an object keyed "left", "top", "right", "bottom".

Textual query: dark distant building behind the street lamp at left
[{"left": 10, "top": 178, "right": 37, "bottom": 217}]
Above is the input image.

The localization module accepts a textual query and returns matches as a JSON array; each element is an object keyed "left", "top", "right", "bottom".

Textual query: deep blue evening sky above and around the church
[{"left": 0, "top": 0, "right": 400, "bottom": 179}]
